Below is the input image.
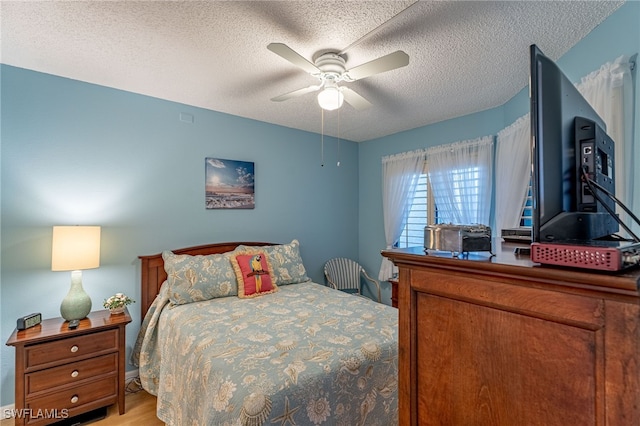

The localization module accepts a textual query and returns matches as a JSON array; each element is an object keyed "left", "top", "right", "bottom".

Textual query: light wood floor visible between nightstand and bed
[{"left": 0, "top": 390, "right": 164, "bottom": 426}]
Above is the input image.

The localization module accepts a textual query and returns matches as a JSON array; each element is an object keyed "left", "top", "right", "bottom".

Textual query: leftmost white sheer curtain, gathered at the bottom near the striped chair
[{"left": 378, "top": 150, "right": 425, "bottom": 281}]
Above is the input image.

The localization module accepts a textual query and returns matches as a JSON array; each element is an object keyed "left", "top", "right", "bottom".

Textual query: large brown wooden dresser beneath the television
[{"left": 382, "top": 243, "right": 640, "bottom": 426}]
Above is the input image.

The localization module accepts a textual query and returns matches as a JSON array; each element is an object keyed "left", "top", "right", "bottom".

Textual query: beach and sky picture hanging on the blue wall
[{"left": 205, "top": 158, "right": 255, "bottom": 210}]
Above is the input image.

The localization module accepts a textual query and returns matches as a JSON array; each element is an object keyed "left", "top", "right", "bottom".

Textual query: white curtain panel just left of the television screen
[{"left": 494, "top": 114, "right": 531, "bottom": 235}]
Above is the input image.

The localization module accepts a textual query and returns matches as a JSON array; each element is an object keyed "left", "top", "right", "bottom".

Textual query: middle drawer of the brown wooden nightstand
[{"left": 25, "top": 353, "right": 118, "bottom": 398}]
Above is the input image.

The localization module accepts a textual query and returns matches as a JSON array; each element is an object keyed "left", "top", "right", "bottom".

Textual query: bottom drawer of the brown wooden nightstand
[{"left": 25, "top": 374, "right": 118, "bottom": 424}]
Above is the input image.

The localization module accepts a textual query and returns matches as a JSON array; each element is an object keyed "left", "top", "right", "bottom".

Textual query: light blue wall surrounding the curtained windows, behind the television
[{"left": 359, "top": 1, "right": 640, "bottom": 303}]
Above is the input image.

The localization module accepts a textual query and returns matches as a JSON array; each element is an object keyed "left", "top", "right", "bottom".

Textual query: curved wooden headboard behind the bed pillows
[{"left": 139, "top": 242, "right": 273, "bottom": 319}]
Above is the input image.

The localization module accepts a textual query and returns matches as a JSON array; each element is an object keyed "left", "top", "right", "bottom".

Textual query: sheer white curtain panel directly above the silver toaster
[{"left": 427, "top": 136, "right": 493, "bottom": 225}]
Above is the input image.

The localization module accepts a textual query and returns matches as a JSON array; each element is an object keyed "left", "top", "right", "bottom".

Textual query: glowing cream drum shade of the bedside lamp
[{"left": 51, "top": 226, "right": 100, "bottom": 271}]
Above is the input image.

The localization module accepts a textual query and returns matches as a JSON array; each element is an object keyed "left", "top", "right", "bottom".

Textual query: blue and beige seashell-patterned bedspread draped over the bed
[{"left": 132, "top": 282, "right": 398, "bottom": 426}]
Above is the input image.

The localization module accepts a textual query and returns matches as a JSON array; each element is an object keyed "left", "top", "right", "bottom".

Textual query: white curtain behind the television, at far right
[{"left": 576, "top": 56, "right": 637, "bottom": 233}]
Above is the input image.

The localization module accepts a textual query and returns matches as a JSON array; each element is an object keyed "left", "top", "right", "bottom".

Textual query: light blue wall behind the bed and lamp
[{"left": 0, "top": 66, "right": 358, "bottom": 406}]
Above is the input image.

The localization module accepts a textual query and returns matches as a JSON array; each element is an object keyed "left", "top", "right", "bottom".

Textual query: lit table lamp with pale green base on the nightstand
[{"left": 51, "top": 226, "right": 100, "bottom": 321}]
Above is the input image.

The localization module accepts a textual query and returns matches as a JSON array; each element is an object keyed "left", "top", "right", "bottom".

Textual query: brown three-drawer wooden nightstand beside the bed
[{"left": 7, "top": 310, "right": 131, "bottom": 425}]
